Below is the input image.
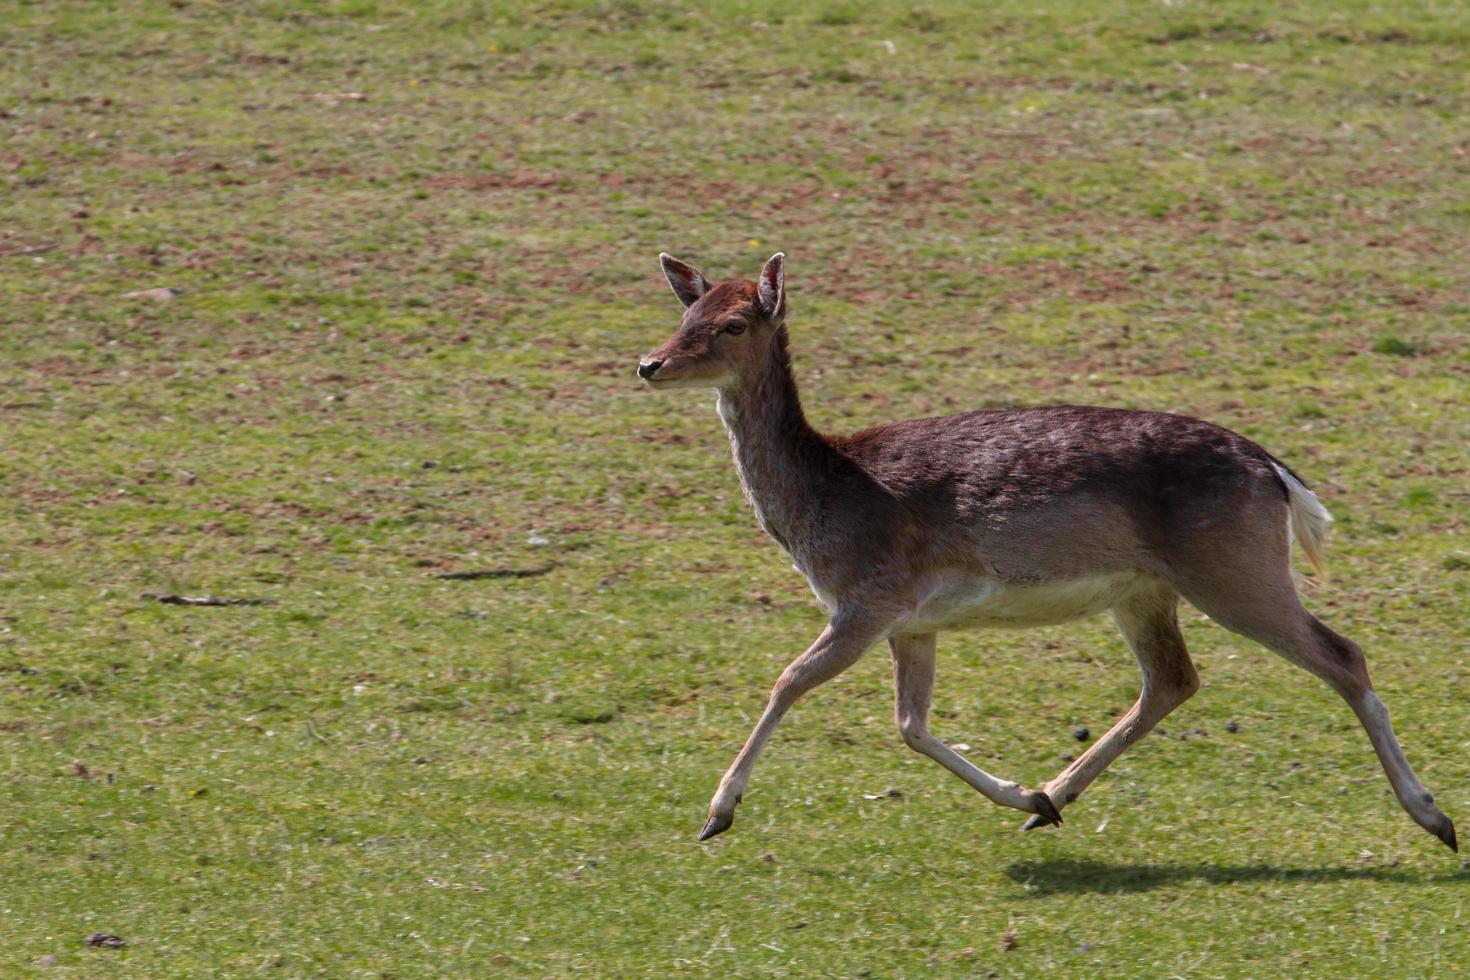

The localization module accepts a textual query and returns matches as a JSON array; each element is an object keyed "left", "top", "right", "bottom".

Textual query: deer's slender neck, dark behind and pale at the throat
[{"left": 717, "top": 326, "right": 833, "bottom": 551}]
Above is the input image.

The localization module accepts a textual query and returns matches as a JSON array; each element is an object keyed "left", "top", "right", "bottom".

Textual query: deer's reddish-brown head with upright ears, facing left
[{"left": 638, "top": 251, "right": 786, "bottom": 388}]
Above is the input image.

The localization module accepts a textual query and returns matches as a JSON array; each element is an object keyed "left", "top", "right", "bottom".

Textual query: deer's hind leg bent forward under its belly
[{"left": 1022, "top": 585, "right": 1200, "bottom": 830}]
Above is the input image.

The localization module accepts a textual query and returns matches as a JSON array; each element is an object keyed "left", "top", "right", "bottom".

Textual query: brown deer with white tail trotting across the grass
[{"left": 638, "top": 253, "right": 1458, "bottom": 851}]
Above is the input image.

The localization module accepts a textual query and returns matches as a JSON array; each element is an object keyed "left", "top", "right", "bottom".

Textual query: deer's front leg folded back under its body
[{"left": 888, "top": 633, "right": 1061, "bottom": 823}]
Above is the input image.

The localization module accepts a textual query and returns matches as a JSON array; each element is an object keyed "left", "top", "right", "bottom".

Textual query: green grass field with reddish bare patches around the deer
[{"left": 0, "top": 0, "right": 1470, "bottom": 977}]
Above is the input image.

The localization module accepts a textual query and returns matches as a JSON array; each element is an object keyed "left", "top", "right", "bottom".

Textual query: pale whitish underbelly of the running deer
[{"left": 904, "top": 572, "right": 1141, "bottom": 632}]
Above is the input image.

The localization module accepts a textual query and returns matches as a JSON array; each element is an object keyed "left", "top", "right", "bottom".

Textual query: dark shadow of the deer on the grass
[{"left": 1005, "top": 858, "right": 1470, "bottom": 898}]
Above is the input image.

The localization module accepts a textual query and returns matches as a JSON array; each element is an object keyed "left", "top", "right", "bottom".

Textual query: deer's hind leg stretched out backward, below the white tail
[{"left": 1185, "top": 561, "right": 1460, "bottom": 851}]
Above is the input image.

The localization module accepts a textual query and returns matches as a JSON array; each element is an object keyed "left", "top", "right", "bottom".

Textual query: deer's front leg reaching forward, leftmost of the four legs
[{"left": 700, "top": 610, "right": 892, "bottom": 840}]
